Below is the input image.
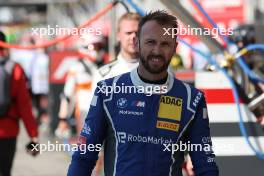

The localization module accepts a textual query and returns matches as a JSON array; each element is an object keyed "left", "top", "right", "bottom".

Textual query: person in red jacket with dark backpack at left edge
[{"left": 0, "top": 32, "right": 38, "bottom": 176}]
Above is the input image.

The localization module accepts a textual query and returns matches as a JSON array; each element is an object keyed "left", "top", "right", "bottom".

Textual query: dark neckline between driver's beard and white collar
[{"left": 137, "top": 65, "right": 168, "bottom": 82}]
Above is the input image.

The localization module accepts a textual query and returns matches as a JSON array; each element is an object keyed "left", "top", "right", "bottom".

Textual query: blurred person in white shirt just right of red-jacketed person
[{"left": 10, "top": 34, "right": 49, "bottom": 131}]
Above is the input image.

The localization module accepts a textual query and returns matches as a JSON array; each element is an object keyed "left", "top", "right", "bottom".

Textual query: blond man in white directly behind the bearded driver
[{"left": 93, "top": 13, "right": 141, "bottom": 81}]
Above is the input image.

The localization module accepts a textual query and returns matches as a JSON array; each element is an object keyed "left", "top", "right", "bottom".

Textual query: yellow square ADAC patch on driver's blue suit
[{"left": 158, "top": 95, "right": 183, "bottom": 121}]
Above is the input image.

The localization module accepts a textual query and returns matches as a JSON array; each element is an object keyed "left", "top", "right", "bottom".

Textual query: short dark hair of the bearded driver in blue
[{"left": 138, "top": 10, "right": 178, "bottom": 37}]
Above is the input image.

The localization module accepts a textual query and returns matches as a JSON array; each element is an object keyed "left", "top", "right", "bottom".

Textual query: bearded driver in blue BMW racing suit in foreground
[{"left": 68, "top": 11, "right": 218, "bottom": 176}]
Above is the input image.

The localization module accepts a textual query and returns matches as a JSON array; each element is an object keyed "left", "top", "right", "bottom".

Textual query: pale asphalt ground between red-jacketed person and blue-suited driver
[{"left": 12, "top": 124, "right": 71, "bottom": 176}]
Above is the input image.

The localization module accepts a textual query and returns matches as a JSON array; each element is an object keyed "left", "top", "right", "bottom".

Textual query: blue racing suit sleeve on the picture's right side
[{"left": 187, "top": 95, "right": 219, "bottom": 176}]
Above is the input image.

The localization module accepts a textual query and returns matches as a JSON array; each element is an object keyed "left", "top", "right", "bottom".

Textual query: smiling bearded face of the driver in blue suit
[{"left": 138, "top": 20, "right": 177, "bottom": 74}]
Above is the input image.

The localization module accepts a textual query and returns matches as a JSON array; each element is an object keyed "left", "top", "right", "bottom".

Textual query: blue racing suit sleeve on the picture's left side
[{"left": 67, "top": 83, "right": 107, "bottom": 176}]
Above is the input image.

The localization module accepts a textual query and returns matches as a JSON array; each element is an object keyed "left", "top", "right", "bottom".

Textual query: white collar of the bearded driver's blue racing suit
[{"left": 130, "top": 68, "right": 174, "bottom": 94}]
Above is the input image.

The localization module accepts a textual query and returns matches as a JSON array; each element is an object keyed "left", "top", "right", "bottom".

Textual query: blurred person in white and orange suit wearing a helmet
[{"left": 55, "top": 34, "right": 108, "bottom": 138}]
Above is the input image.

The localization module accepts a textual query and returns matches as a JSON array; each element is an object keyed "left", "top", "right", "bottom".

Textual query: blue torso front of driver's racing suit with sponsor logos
[{"left": 101, "top": 73, "right": 196, "bottom": 176}]
